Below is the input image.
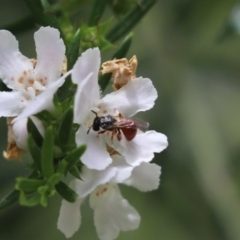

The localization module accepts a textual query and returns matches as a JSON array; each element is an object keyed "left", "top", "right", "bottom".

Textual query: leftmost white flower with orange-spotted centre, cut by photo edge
[{"left": 0, "top": 27, "right": 69, "bottom": 148}]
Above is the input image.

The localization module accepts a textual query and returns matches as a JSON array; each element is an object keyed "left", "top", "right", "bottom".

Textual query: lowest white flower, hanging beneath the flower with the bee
[{"left": 57, "top": 155, "right": 161, "bottom": 240}]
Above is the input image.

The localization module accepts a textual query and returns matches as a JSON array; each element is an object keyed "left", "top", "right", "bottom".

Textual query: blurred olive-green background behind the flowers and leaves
[{"left": 0, "top": 0, "right": 240, "bottom": 240}]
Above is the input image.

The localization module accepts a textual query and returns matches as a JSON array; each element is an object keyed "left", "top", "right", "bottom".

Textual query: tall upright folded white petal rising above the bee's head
[{"left": 72, "top": 48, "right": 100, "bottom": 123}]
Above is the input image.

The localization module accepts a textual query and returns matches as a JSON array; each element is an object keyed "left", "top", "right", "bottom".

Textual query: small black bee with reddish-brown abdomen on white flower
[{"left": 87, "top": 111, "right": 149, "bottom": 141}]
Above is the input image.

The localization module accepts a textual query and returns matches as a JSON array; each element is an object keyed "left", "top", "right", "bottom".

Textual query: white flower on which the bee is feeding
[{"left": 72, "top": 48, "right": 168, "bottom": 170}]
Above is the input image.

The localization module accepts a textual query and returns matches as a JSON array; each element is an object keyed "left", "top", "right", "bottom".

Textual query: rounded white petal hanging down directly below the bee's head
[{"left": 76, "top": 125, "right": 112, "bottom": 170}]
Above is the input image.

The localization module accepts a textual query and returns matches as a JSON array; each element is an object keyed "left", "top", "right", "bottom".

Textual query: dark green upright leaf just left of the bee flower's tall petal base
[{"left": 59, "top": 106, "right": 73, "bottom": 145}]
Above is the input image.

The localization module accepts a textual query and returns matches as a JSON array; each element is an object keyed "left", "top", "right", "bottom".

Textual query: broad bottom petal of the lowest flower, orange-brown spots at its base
[{"left": 90, "top": 185, "right": 140, "bottom": 240}]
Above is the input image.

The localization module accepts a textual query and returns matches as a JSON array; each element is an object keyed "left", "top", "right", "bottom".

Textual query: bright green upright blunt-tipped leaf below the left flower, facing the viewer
[{"left": 41, "top": 126, "right": 54, "bottom": 178}]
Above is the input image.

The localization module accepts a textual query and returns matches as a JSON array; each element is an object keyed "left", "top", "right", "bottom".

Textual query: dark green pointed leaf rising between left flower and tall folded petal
[{"left": 66, "top": 29, "right": 81, "bottom": 69}]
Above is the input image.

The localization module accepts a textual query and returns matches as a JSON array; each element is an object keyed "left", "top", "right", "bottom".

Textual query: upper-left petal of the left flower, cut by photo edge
[{"left": 0, "top": 30, "right": 33, "bottom": 89}]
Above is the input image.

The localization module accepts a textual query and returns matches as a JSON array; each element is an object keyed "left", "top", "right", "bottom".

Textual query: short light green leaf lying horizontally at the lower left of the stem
[{"left": 15, "top": 177, "right": 45, "bottom": 193}]
